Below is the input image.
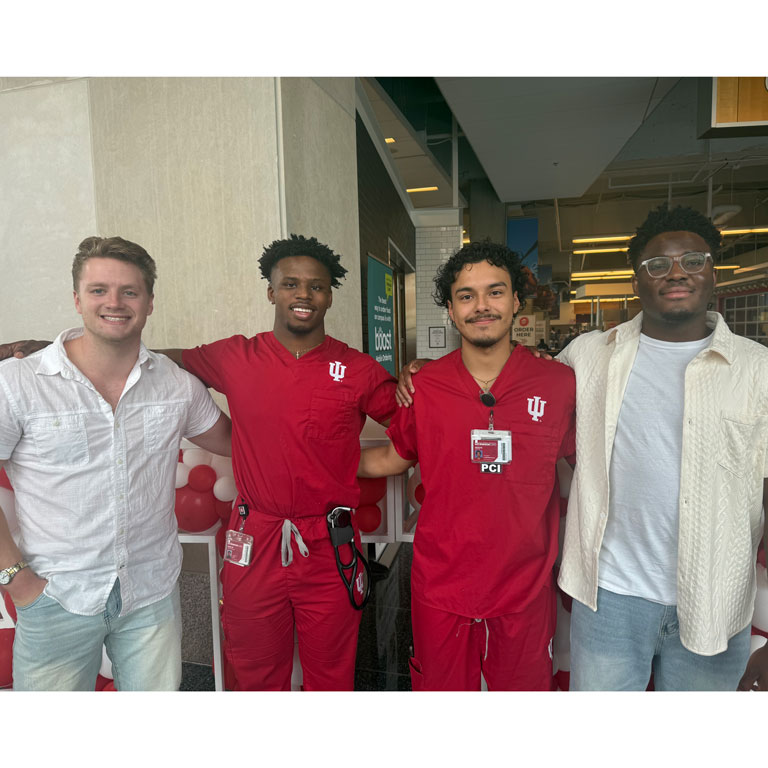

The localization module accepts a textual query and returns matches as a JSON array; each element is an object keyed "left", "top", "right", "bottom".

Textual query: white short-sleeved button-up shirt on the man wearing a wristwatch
[{"left": 0, "top": 328, "right": 220, "bottom": 615}]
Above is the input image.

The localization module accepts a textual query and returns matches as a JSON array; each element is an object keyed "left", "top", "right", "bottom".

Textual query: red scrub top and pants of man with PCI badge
[{"left": 388, "top": 346, "right": 576, "bottom": 690}]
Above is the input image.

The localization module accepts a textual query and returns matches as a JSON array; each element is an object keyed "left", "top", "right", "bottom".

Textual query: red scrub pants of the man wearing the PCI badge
[{"left": 410, "top": 586, "right": 557, "bottom": 691}]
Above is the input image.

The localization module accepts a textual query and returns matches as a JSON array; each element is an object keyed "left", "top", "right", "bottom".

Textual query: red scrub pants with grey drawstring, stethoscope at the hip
[{"left": 221, "top": 506, "right": 362, "bottom": 691}]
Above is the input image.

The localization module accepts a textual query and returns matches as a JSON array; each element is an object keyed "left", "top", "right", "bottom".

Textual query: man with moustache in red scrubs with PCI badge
[{"left": 359, "top": 243, "right": 575, "bottom": 690}]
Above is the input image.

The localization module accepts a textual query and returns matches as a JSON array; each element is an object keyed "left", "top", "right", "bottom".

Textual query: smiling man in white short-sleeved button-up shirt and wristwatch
[{"left": 0, "top": 237, "right": 231, "bottom": 690}]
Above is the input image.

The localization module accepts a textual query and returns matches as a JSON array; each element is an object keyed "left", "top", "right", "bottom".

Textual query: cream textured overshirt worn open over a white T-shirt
[{"left": 558, "top": 312, "right": 768, "bottom": 656}]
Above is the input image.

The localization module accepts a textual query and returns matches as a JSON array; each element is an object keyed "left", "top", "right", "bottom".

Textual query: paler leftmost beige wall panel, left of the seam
[{"left": 0, "top": 78, "right": 96, "bottom": 341}]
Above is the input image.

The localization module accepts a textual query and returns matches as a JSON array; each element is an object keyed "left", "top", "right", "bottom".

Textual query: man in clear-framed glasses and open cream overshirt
[{"left": 559, "top": 205, "right": 768, "bottom": 690}]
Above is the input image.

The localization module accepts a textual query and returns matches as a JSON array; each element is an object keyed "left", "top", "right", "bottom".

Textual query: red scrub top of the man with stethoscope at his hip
[{"left": 182, "top": 331, "right": 397, "bottom": 518}]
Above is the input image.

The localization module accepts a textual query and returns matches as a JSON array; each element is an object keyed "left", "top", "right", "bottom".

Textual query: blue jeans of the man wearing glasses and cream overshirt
[{"left": 570, "top": 588, "right": 751, "bottom": 691}]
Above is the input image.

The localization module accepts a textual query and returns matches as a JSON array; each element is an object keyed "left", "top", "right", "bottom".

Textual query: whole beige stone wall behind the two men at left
[{"left": 0, "top": 78, "right": 362, "bottom": 347}]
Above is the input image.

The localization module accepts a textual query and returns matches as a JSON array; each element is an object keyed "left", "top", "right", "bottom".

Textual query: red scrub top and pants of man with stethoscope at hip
[{"left": 183, "top": 332, "right": 396, "bottom": 690}]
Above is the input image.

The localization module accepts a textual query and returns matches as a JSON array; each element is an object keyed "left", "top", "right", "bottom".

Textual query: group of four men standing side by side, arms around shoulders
[{"left": 0, "top": 206, "right": 768, "bottom": 690}]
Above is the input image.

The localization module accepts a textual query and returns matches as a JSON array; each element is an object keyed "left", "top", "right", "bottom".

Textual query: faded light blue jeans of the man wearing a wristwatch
[{"left": 13, "top": 580, "right": 181, "bottom": 691}]
